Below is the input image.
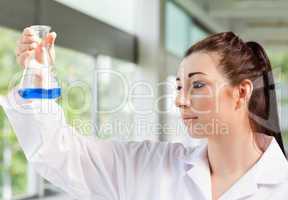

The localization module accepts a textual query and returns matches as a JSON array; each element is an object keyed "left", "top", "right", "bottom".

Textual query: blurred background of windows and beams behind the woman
[{"left": 0, "top": 0, "right": 288, "bottom": 200}]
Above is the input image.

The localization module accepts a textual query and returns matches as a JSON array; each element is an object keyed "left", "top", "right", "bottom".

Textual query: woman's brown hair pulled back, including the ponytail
[{"left": 184, "top": 32, "right": 286, "bottom": 156}]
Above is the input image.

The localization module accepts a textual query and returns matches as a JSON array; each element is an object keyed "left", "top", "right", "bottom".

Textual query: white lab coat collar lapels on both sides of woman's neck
[{"left": 183, "top": 137, "right": 288, "bottom": 200}]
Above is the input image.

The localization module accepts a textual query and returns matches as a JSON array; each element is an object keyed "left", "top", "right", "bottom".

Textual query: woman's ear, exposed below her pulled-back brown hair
[{"left": 233, "top": 79, "right": 253, "bottom": 109}]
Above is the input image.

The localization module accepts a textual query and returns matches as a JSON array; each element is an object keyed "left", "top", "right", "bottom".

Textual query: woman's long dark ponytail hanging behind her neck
[{"left": 246, "top": 42, "right": 286, "bottom": 157}]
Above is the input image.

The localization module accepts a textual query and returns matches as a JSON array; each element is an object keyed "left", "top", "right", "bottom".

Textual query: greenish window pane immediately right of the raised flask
[{"left": 55, "top": 47, "right": 95, "bottom": 135}]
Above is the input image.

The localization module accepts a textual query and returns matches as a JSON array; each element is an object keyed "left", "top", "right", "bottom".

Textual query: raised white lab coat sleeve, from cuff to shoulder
[{"left": 0, "top": 88, "right": 183, "bottom": 199}]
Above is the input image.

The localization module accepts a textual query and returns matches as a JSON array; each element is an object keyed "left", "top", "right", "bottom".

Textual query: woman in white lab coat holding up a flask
[{"left": 3, "top": 28, "right": 288, "bottom": 200}]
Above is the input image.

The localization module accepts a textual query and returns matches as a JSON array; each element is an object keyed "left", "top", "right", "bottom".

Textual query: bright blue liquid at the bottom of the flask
[{"left": 18, "top": 88, "right": 61, "bottom": 99}]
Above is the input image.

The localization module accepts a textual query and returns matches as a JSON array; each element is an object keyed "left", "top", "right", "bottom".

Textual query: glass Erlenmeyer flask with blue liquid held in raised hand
[{"left": 19, "top": 25, "right": 61, "bottom": 99}]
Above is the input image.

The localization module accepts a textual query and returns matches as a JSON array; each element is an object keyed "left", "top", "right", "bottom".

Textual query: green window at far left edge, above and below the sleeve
[{"left": 0, "top": 27, "right": 28, "bottom": 199}]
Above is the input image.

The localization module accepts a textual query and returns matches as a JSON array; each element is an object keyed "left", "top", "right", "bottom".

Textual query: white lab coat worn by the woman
[{"left": 1, "top": 90, "right": 288, "bottom": 200}]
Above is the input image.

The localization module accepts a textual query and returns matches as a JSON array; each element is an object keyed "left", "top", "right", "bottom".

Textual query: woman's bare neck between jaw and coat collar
[{"left": 208, "top": 129, "right": 263, "bottom": 178}]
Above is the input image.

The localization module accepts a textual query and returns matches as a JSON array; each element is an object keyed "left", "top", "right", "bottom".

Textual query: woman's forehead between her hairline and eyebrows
[{"left": 177, "top": 52, "right": 221, "bottom": 79}]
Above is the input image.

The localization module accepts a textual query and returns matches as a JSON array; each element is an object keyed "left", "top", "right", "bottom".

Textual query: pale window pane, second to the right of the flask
[{"left": 96, "top": 56, "right": 136, "bottom": 139}]
